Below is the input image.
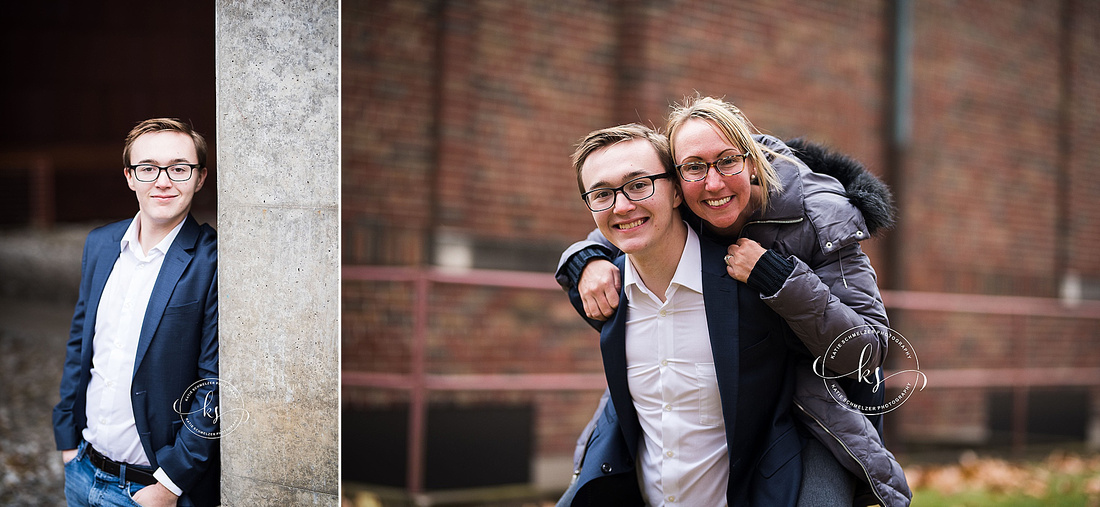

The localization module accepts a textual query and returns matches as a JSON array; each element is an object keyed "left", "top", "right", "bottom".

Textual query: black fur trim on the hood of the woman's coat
[{"left": 787, "top": 137, "right": 898, "bottom": 235}]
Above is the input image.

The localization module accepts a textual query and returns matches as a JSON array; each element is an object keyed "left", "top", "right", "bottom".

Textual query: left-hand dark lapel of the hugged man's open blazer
[{"left": 600, "top": 255, "right": 640, "bottom": 456}]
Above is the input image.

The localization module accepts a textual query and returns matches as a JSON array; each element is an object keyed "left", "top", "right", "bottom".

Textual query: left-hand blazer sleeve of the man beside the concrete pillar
[{"left": 54, "top": 230, "right": 95, "bottom": 451}]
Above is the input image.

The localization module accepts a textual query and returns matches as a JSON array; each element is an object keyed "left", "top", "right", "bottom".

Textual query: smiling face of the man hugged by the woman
[{"left": 581, "top": 139, "right": 683, "bottom": 256}]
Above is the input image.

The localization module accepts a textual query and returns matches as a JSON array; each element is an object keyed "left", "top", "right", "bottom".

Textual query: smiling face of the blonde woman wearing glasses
[{"left": 671, "top": 118, "right": 756, "bottom": 236}]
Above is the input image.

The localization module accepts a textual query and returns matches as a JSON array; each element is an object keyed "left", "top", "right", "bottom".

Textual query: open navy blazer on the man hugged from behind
[{"left": 570, "top": 233, "right": 802, "bottom": 506}]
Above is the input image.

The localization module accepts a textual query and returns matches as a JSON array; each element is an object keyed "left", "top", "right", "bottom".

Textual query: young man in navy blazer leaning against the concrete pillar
[{"left": 54, "top": 118, "right": 220, "bottom": 506}]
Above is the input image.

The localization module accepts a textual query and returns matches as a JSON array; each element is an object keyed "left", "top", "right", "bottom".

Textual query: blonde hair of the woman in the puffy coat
[{"left": 666, "top": 95, "right": 789, "bottom": 208}]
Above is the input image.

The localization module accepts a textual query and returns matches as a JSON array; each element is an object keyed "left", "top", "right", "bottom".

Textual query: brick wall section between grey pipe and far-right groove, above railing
[{"left": 902, "top": 1, "right": 1060, "bottom": 296}]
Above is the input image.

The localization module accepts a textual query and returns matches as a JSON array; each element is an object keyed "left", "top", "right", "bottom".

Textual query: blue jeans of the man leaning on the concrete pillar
[{"left": 65, "top": 442, "right": 145, "bottom": 507}]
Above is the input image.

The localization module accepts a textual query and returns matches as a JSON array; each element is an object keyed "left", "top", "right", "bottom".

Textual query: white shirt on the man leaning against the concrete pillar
[{"left": 83, "top": 212, "right": 184, "bottom": 475}]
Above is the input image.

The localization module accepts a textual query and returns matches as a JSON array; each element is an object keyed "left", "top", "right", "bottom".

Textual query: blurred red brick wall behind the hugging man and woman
[{"left": 343, "top": 0, "right": 1100, "bottom": 481}]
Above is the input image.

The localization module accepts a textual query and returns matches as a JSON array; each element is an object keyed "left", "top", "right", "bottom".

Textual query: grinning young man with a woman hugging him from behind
[{"left": 562, "top": 124, "right": 802, "bottom": 506}]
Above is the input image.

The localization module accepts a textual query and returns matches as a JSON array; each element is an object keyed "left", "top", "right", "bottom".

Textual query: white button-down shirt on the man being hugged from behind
[{"left": 623, "top": 227, "right": 729, "bottom": 506}]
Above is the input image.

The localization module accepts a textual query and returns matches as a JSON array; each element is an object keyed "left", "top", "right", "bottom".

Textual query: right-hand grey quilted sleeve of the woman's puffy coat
[{"left": 762, "top": 238, "right": 890, "bottom": 378}]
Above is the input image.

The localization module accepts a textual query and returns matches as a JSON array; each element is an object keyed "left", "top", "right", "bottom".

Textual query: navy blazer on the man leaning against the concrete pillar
[{"left": 54, "top": 214, "right": 221, "bottom": 506}]
